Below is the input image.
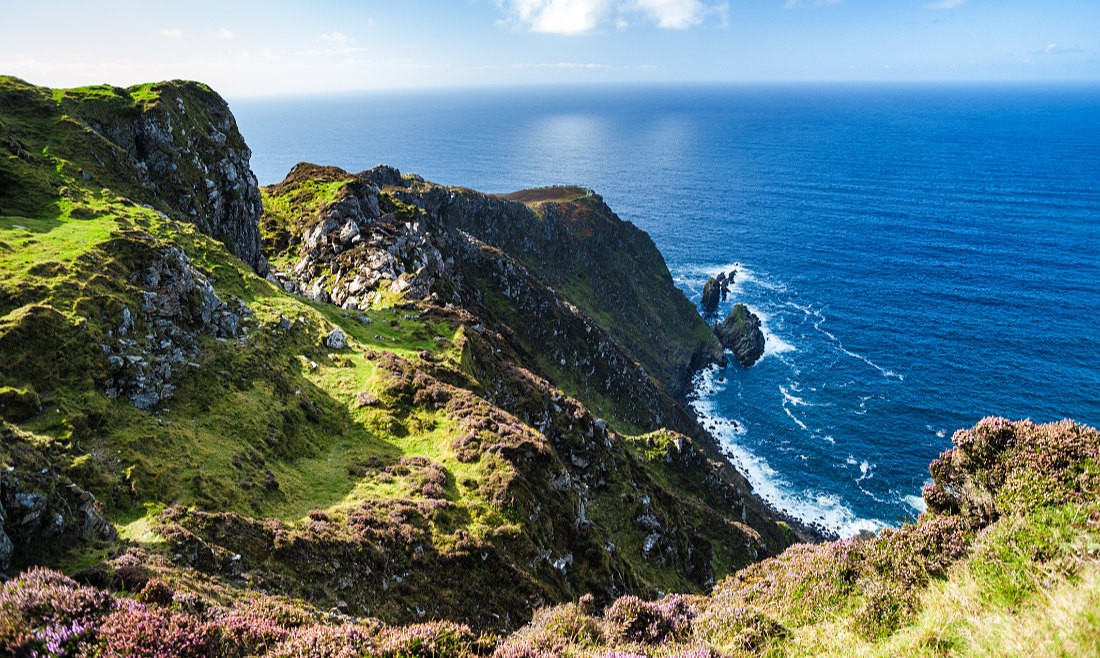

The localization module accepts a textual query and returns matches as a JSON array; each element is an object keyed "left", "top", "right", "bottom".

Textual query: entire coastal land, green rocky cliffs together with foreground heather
[{"left": 0, "top": 77, "right": 1100, "bottom": 656}]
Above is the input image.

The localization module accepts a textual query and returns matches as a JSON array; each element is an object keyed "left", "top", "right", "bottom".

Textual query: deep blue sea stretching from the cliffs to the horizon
[{"left": 231, "top": 85, "right": 1100, "bottom": 535}]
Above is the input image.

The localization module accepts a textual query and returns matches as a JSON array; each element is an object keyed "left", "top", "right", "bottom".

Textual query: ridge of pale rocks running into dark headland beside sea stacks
[{"left": 266, "top": 164, "right": 725, "bottom": 396}]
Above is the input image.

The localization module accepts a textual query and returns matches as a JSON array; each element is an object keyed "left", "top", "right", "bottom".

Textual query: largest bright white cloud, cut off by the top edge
[{"left": 497, "top": 0, "right": 729, "bottom": 34}]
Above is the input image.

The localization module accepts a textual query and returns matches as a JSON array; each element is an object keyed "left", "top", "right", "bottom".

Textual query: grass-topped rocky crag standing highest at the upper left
[{"left": 0, "top": 77, "right": 266, "bottom": 273}]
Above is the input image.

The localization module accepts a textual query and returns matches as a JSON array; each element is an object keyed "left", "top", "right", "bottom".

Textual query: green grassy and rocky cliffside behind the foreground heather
[{"left": 0, "top": 78, "right": 793, "bottom": 632}]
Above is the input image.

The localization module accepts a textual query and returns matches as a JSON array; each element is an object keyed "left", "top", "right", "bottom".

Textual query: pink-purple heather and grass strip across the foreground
[{"left": 0, "top": 418, "right": 1100, "bottom": 658}]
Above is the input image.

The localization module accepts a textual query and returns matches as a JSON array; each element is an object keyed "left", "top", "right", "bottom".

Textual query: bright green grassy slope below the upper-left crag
[{"left": 0, "top": 78, "right": 503, "bottom": 561}]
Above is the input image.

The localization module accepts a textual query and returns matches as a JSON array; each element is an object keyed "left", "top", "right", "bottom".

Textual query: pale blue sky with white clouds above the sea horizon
[{"left": 0, "top": 0, "right": 1100, "bottom": 97}]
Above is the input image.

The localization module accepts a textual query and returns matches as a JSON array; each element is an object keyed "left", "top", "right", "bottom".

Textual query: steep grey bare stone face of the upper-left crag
[{"left": 77, "top": 83, "right": 266, "bottom": 273}]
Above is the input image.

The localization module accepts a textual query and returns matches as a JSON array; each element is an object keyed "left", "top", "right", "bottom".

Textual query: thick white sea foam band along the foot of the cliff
[{"left": 691, "top": 366, "right": 886, "bottom": 537}]
